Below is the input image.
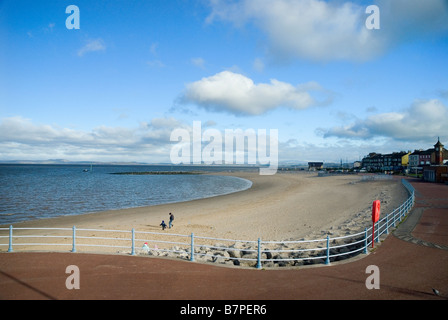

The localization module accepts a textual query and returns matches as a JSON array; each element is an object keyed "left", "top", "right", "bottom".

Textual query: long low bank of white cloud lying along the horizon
[{"left": 0, "top": 117, "right": 416, "bottom": 163}]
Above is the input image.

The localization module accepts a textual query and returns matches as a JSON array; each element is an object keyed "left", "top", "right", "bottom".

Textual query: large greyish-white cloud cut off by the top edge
[{"left": 207, "top": 0, "right": 448, "bottom": 61}]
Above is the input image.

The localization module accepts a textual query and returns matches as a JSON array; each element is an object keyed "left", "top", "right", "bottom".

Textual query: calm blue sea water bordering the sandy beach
[{"left": 0, "top": 165, "right": 252, "bottom": 225}]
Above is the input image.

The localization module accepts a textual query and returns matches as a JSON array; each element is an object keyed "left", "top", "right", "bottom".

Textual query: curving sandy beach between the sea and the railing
[{"left": 2, "top": 172, "right": 408, "bottom": 241}]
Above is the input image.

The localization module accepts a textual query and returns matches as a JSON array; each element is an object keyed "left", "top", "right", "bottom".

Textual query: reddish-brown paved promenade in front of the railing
[{"left": 0, "top": 180, "right": 448, "bottom": 303}]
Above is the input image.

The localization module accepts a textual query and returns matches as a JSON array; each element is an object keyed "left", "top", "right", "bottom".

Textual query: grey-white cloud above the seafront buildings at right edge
[{"left": 323, "top": 99, "right": 448, "bottom": 141}]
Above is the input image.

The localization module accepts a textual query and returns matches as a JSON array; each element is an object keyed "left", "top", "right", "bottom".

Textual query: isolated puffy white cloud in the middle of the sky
[{"left": 180, "top": 71, "right": 331, "bottom": 115}]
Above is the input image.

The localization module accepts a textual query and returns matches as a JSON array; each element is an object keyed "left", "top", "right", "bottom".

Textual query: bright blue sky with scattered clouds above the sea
[{"left": 0, "top": 0, "right": 448, "bottom": 163}]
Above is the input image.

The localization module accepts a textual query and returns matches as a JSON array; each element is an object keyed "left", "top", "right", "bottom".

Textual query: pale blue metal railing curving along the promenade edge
[{"left": 0, "top": 179, "right": 415, "bottom": 269}]
